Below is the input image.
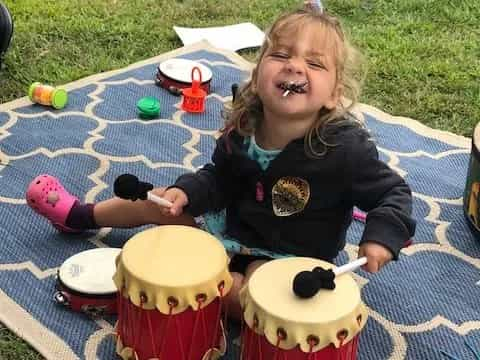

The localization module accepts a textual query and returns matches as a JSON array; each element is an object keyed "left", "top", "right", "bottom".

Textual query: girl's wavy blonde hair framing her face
[{"left": 222, "top": 9, "right": 364, "bottom": 156}]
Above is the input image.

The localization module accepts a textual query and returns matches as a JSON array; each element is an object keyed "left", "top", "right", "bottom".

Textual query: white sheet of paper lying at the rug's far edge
[{"left": 173, "top": 23, "right": 265, "bottom": 51}]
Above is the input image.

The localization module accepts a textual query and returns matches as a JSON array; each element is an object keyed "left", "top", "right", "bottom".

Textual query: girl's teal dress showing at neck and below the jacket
[{"left": 198, "top": 136, "right": 291, "bottom": 258}]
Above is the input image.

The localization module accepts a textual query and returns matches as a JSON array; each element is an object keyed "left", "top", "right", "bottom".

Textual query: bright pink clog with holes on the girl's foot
[{"left": 27, "top": 174, "right": 79, "bottom": 233}]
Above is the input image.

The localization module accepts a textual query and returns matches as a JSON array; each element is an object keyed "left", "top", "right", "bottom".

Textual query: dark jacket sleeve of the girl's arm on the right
[{"left": 349, "top": 129, "right": 416, "bottom": 260}]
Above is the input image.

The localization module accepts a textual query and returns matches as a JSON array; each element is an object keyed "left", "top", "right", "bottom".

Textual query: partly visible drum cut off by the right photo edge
[{"left": 463, "top": 123, "right": 480, "bottom": 238}]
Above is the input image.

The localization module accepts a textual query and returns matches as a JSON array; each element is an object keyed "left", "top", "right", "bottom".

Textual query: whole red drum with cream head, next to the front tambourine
[{"left": 114, "top": 225, "right": 232, "bottom": 360}]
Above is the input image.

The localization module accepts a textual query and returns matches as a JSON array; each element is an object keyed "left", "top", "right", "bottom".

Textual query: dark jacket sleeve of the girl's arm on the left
[{"left": 171, "top": 138, "right": 231, "bottom": 216}]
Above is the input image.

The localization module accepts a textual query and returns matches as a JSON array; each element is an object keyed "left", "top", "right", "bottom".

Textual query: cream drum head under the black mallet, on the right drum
[{"left": 241, "top": 257, "right": 367, "bottom": 352}]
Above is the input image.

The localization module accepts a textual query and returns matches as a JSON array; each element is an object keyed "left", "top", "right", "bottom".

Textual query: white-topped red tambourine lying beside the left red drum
[{"left": 54, "top": 248, "right": 120, "bottom": 317}]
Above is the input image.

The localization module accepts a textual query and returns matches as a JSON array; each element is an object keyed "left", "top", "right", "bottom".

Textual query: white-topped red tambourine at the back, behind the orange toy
[{"left": 155, "top": 58, "right": 212, "bottom": 95}]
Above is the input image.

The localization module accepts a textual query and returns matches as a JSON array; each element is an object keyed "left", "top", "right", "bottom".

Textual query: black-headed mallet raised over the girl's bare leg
[{"left": 113, "top": 174, "right": 172, "bottom": 207}]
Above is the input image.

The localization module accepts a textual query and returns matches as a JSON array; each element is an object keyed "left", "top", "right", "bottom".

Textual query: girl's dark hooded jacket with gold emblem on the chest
[{"left": 174, "top": 122, "right": 415, "bottom": 261}]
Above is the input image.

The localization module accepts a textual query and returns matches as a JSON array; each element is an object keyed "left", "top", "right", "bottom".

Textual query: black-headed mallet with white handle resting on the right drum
[{"left": 293, "top": 257, "right": 367, "bottom": 298}]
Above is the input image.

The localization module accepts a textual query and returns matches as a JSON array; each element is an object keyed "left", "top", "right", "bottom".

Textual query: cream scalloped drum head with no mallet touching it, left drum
[{"left": 114, "top": 225, "right": 232, "bottom": 312}]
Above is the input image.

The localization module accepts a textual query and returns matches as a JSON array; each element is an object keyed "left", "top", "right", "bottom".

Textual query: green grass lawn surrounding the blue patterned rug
[{"left": 0, "top": 0, "right": 480, "bottom": 359}]
